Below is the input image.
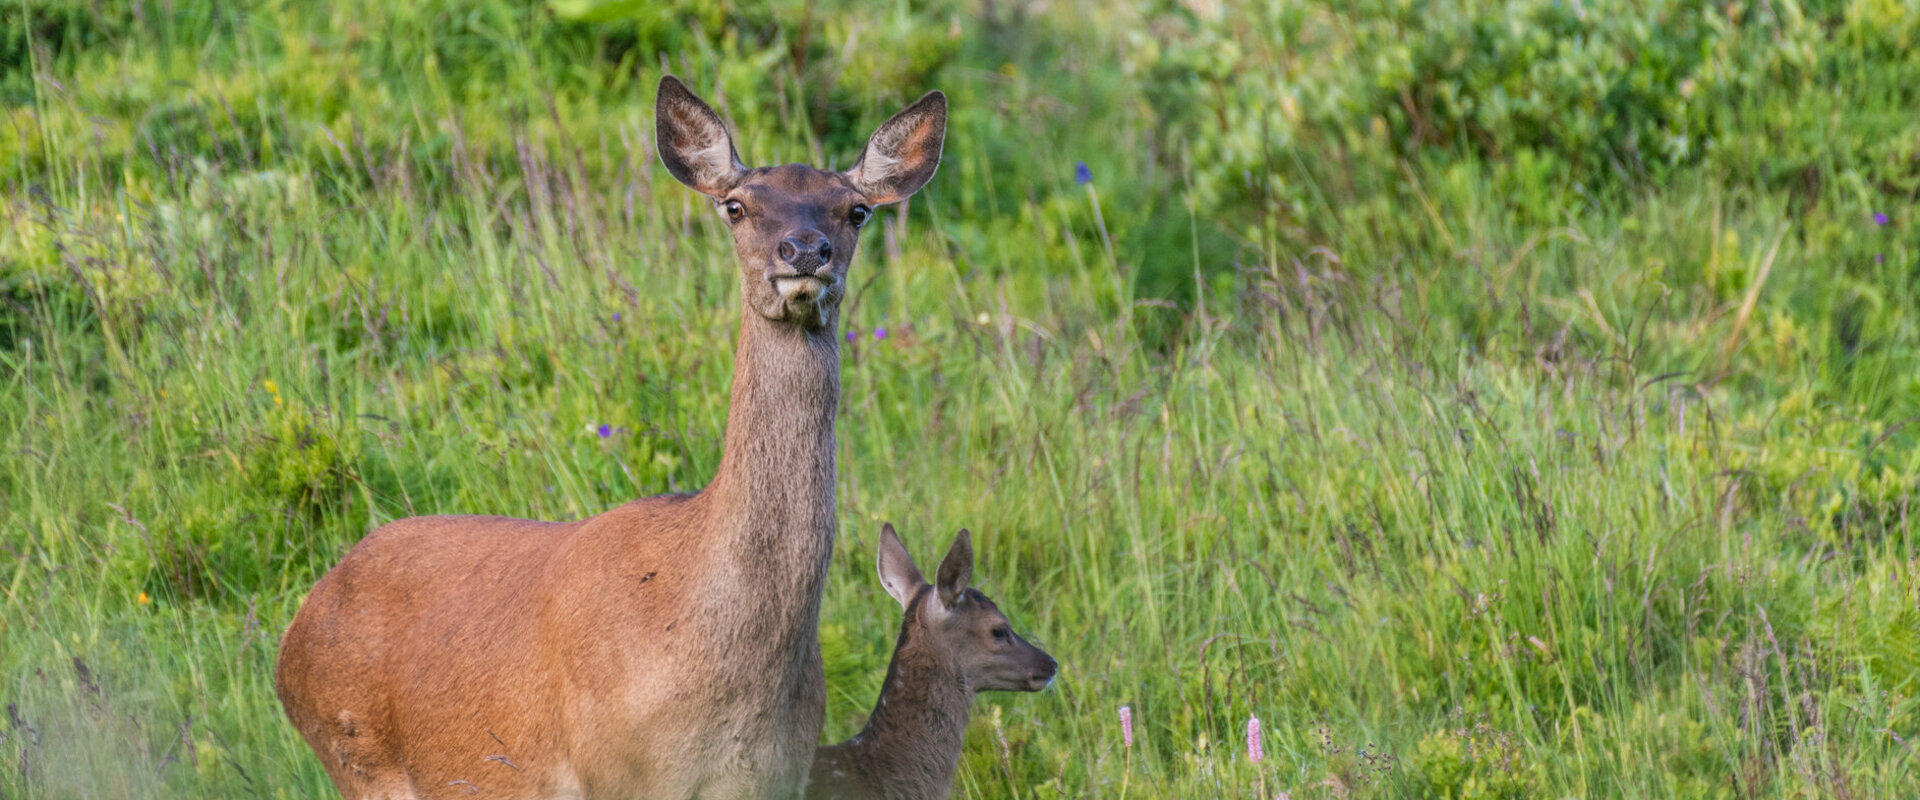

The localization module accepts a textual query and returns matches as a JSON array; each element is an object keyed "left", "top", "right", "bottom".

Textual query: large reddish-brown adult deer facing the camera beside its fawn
[{"left": 276, "top": 77, "right": 947, "bottom": 800}]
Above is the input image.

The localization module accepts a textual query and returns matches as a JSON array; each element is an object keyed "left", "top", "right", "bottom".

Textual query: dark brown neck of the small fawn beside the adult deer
[{"left": 845, "top": 631, "right": 973, "bottom": 798}]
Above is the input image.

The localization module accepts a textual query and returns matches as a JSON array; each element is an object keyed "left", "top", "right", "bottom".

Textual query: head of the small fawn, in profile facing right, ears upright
[{"left": 879, "top": 524, "right": 1058, "bottom": 693}]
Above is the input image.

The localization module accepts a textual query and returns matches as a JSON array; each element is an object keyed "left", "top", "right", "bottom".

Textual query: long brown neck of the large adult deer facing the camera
[{"left": 705, "top": 309, "right": 839, "bottom": 598}]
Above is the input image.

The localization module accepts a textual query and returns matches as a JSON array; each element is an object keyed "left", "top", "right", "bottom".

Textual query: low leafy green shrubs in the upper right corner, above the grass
[{"left": 1127, "top": 0, "right": 1920, "bottom": 214}]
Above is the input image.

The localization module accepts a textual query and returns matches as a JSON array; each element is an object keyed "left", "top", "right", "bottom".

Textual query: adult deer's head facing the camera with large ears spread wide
[{"left": 655, "top": 75, "right": 947, "bottom": 330}]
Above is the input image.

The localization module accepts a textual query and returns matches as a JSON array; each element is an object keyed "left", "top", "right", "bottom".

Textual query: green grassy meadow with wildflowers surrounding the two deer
[{"left": 0, "top": 0, "right": 1920, "bottom": 800}]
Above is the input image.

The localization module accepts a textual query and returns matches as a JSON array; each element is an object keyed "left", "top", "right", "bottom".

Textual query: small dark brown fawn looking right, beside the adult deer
[{"left": 806, "top": 524, "right": 1056, "bottom": 800}]
